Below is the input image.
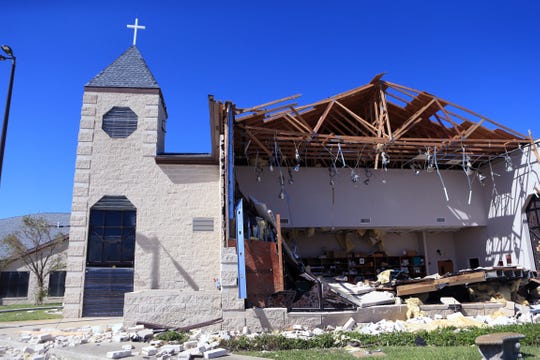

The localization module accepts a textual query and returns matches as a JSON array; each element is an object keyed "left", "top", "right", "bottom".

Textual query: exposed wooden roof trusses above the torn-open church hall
[{"left": 234, "top": 74, "right": 532, "bottom": 169}]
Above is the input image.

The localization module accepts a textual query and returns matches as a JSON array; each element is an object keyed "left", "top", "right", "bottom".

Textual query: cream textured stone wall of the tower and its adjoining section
[{"left": 64, "top": 89, "right": 223, "bottom": 323}]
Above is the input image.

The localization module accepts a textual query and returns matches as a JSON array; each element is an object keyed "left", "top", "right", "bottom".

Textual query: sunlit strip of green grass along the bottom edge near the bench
[{"left": 243, "top": 346, "right": 540, "bottom": 360}]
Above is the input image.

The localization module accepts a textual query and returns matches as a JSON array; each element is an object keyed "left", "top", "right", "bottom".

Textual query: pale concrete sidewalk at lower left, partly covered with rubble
[{"left": 0, "top": 318, "right": 262, "bottom": 360}]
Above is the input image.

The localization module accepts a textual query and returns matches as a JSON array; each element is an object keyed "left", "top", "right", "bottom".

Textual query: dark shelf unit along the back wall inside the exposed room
[{"left": 302, "top": 255, "right": 426, "bottom": 282}]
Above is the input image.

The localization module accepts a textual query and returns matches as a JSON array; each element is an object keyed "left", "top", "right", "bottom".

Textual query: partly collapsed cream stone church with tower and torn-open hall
[{"left": 64, "top": 46, "right": 540, "bottom": 329}]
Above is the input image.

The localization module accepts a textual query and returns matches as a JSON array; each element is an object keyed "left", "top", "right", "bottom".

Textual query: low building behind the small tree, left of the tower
[{"left": 0, "top": 213, "right": 70, "bottom": 305}]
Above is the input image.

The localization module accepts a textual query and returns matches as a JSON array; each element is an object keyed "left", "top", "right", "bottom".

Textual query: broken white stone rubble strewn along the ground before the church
[{"left": 0, "top": 298, "right": 540, "bottom": 360}]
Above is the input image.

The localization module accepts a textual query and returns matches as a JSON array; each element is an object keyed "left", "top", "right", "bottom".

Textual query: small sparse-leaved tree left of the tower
[{"left": 1, "top": 216, "right": 65, "bottom": 304}]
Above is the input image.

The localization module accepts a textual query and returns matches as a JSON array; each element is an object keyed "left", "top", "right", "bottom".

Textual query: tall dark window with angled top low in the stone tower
[{"left": 86, "top": 196, "right": 137, "bottom": 267}]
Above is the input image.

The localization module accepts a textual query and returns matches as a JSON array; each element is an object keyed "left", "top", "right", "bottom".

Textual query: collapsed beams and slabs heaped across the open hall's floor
[{"left": 306, "top": 267, "right": 540, "bottom": 308}]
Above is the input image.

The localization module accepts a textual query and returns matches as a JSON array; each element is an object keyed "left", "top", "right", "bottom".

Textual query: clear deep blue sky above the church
[{"left": 0, "top": 0, "right": 540, "bottom": 218}]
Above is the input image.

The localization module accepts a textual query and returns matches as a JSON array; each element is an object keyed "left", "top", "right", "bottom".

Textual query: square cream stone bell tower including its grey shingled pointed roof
[{"left": 64, "top": 44, "right": 167, "bottom": 317}]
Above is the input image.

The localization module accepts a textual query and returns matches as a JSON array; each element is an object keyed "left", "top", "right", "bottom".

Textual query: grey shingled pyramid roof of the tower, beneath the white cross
[{"left": 85, "top": 45, "right": 159, "bottom": 89}]
